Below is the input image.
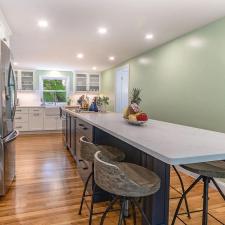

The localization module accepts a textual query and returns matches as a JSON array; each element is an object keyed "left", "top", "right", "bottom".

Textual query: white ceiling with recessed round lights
[{"left": 0, "top": 0, "right": 225, "bottom": 70}]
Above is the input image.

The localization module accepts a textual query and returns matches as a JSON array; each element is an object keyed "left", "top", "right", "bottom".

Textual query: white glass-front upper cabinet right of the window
[{"left": 75, "top": 73, "right": 100, "bottom": 93}]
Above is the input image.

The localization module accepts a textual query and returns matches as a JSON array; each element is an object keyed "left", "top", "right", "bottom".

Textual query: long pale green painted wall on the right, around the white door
[{"left": 101, "top": 19, "right": 225, "bottom": 132}]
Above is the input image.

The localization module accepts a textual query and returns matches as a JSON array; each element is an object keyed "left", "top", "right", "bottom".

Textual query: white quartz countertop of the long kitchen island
[{"left": 66, "top": 110, "right": 225, "bottom": 165}]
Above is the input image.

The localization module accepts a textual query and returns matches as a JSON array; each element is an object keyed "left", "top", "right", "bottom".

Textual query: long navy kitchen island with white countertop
[{"left": 64, "top": 109, "right": 225, "bottom": 225}]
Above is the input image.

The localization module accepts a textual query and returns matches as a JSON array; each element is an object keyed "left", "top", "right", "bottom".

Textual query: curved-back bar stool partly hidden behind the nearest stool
[{"left": 79, "top": 136, "right": 125, "bottom": 225}]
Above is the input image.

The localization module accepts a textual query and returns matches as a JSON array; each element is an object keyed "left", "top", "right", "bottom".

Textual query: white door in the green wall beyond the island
[{"left": 116, "top": 65, "right": 129, "bottom": 112}]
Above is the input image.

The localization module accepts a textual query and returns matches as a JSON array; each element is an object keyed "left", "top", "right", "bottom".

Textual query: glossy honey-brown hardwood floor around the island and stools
[{"left": 0, "top": 135, "right": 225, "bottom": 225}]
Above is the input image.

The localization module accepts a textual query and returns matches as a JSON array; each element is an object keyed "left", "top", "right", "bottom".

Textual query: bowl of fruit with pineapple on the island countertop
[{"left": 123, "top": 88, "right": 148, "bottom": 126}]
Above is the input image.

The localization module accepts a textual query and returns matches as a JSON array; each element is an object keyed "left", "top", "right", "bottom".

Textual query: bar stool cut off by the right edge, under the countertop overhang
[{"left": 172, "top": 161, "right": 225, "bottom": 225}]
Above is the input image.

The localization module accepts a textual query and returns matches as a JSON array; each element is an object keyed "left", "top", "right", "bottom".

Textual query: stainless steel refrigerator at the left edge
[{"left": 0, "top": 41, "right": 18, "bottom": 195}]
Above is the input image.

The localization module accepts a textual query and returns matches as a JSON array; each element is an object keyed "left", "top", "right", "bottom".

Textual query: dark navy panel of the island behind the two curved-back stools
[{"left": 94, "top": 128, "right": 170, "bottom": 225}]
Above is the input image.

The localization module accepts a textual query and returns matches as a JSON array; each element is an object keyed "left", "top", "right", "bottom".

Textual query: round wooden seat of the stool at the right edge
[{"left": 181, "top": 161, "right": 225, "bottom": 178}]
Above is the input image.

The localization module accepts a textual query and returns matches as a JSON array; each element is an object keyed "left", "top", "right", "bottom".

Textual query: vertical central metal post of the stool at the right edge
[{"left": 202, "top": 177, "right": 210, "bottom": 225}]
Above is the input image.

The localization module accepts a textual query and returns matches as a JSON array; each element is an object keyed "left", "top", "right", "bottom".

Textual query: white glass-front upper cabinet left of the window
[{"left": 15, "top": 70, "right": 34, "bottom": 91}]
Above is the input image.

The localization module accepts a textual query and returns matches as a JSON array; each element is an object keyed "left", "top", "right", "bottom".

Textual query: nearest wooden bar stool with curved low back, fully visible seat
[{"left": 94, "top": 151, "right": 160, "bottom": 225}]
